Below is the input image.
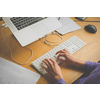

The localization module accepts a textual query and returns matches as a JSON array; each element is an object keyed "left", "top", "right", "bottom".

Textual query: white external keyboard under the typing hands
[{"left": 32, "top": 36, "right": 86, "bottom": 75}]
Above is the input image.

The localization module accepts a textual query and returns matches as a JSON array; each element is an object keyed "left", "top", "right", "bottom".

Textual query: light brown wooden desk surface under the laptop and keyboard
[{"left": 0, "top": 17, "right": 100, "bottom": 84}]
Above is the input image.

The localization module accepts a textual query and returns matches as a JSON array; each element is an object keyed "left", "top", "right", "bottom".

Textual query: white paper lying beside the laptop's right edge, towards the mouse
[{"left": 56, "top": 17, "right": 81, "bottom": 35}]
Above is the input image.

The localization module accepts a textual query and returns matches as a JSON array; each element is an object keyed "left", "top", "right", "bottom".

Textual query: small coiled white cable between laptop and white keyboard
[{"left": 44, "top": 32, "right": 63, "bottom": 46}]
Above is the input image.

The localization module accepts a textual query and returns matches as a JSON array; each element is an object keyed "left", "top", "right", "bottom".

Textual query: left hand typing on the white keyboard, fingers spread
[{"left": 42, "top": 59, "right": 63, "bottom": 81}]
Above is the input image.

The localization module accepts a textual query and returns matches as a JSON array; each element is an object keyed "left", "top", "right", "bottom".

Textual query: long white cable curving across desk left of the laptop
[{"left": 1, "top": 27, "right": 33, "bottom": 65}]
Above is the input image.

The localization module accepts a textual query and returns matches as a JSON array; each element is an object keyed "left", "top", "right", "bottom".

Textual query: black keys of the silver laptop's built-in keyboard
[{"left": 10, "top": 17, "right": 47, "bottom": 30}]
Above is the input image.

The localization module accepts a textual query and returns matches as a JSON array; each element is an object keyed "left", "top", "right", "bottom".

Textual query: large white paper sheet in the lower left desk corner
[{"left": 0, "top": 57, "right": 40, "bottom": 84}]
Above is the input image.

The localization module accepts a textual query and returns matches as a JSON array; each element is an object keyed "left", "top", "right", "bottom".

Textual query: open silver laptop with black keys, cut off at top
[{"left": 3, "top": 17, "right": 62, "bottom": 47}]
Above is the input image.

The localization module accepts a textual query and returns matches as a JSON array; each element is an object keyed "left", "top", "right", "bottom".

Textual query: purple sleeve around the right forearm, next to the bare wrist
[{"left": 85, "top": 61, "right": 100, "bottom": 72}]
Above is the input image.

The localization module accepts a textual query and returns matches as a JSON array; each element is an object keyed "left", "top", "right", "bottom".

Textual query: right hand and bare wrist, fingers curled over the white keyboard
[{"left": 56, "top": 49, "right": 85, "bottom": 67}]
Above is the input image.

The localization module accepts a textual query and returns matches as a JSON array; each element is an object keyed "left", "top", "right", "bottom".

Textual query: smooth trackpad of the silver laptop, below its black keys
[{"left": 32, "top": 23, "right": 48, "bottom": 36}]
